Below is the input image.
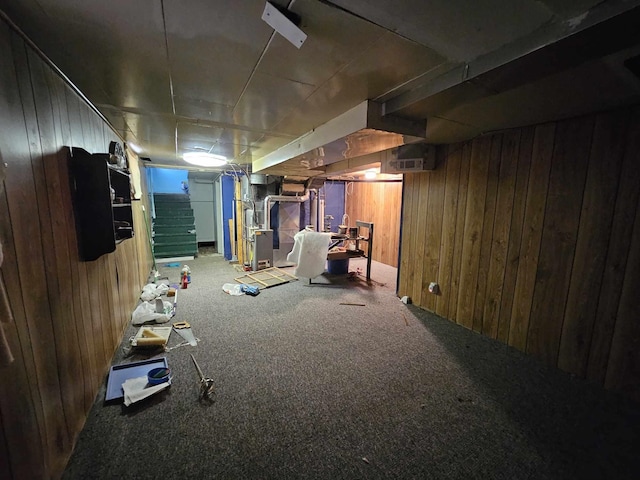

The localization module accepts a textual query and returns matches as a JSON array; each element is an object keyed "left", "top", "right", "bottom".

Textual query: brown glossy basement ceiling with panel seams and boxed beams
[{"left": 0, "top": 0, "right": 640, "bottom": 177}]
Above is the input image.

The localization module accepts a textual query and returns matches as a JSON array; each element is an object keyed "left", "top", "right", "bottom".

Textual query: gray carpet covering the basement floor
[{"left": 64, "top": 255, "right": 640, "bottom": 479}]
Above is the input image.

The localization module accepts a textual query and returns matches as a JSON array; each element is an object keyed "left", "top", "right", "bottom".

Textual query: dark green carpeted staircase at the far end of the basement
[{"left": 153, "top": 193, "right": 198, "bottom": 258}]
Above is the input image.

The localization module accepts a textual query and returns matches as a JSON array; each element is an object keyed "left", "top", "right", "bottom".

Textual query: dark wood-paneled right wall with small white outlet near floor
[{"left": 399, "top": 108, "right": 640, "bottom": 399}]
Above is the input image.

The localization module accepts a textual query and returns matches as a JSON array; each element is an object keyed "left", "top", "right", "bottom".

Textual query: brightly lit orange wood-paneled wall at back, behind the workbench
[{"left": 345, "top": 182, "right": 402, "bottom": 267}]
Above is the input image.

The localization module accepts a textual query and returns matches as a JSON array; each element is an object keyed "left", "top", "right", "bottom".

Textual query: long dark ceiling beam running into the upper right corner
[{"left": 383, "top": 0, "right": 640, "bottom": 115}]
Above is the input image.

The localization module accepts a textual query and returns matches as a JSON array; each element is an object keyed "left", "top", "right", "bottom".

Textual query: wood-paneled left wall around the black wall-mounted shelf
[{"left": 0, "top": 22, "right": 151, "bottom": 479}]
